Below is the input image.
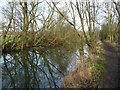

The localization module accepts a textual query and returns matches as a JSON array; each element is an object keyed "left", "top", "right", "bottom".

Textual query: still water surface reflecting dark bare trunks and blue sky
[{"left": 1, "top": 48, "right": 79, "bottom": 88}]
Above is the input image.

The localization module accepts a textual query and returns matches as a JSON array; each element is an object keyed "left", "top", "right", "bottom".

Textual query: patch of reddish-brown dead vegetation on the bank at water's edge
[{"left": 62, "top": 58, "right": 95, "bottom": 88}]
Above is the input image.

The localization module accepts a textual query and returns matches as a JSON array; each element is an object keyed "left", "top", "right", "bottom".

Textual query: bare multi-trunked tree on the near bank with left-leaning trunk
[{"left": 53, "top": 0, "right": 98, "bottom": 58}]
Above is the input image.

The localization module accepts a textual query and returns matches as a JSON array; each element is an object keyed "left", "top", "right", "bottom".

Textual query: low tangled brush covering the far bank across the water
[{"left": 2, "top": 30, "right": 81, "bottom": 52}]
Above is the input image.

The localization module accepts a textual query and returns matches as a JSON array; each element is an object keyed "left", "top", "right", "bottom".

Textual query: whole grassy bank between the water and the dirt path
[{"left": 62, "top": 43, "right": 105, "bottom": 88}]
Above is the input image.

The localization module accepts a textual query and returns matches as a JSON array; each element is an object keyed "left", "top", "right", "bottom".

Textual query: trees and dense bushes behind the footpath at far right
[{"left": 100, "top": 1, "right": 120, "bottom": 46}]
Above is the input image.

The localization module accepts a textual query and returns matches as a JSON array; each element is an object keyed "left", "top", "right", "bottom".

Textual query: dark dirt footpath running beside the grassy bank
[{"left": 103, "top": 42, "right": 120, "bottom": 88}]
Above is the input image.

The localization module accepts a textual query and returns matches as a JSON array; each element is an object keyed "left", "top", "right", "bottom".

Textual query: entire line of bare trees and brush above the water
[{"left": 2, "top": 0, "right": 119, "bottom": 55}]
